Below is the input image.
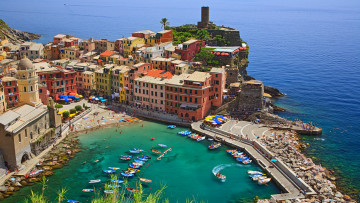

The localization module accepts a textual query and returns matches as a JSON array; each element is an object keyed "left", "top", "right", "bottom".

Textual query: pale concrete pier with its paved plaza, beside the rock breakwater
[{"left": 191, "top": 120, "right": 316, "bottom": 201}]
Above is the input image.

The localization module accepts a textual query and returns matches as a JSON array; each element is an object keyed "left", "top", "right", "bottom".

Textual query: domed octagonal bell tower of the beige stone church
[{"left": 16, "top": 57, "right": 42, "bottom": 107}]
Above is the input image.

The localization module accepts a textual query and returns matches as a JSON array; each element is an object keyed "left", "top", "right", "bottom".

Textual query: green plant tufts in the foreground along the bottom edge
[{"left": 25, "top": 176, "right": 169, "bottom": 203}]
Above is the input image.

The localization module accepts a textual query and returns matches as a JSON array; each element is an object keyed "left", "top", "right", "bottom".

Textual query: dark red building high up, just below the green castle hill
[{"left": 175, "top": 39, "right": 205, "bottom": 61}]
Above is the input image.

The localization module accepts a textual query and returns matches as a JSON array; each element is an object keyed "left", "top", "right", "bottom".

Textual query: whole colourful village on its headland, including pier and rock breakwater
[{"left": 0, "top": 7, "right": 352, "bottom": 202}]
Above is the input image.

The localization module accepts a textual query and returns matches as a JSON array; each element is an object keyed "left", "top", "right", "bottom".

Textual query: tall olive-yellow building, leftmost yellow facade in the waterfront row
[{"left": 95, "top": 64, "right": 114, "bottom": 96}]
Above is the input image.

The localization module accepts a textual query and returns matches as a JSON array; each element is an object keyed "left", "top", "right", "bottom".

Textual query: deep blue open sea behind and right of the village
[{"left": 0, "top": 0, "right": 360, "bottom": 199}]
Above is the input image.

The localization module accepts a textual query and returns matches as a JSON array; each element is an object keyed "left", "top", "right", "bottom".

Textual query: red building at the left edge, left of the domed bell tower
[{"left": 1, "top": 77, "right": 19, "bottom": 108}]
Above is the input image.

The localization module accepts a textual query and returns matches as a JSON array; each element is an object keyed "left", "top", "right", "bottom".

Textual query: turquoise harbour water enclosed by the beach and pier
[{"left": 4, "top": 122, "right": 280, "bottom": 202}]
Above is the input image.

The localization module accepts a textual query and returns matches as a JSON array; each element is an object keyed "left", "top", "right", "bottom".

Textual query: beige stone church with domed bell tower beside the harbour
[{"left": 0, "top": 58, "right": 59, "bottom": 169}]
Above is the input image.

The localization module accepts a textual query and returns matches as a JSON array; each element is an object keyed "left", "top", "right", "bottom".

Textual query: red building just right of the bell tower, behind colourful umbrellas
[{"left": 37, "top": 66, "right": 77, "bottom": 101}]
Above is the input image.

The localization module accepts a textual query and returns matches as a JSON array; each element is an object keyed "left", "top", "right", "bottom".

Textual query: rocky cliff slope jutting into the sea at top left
[{"left": 0, "top": 19, "right": 41, "bottom": 43}]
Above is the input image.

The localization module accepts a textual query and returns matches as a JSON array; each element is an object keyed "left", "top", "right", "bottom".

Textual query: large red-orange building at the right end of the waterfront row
[{"left": 165, "top": 68, "right": 226, "bottom": 121}]
